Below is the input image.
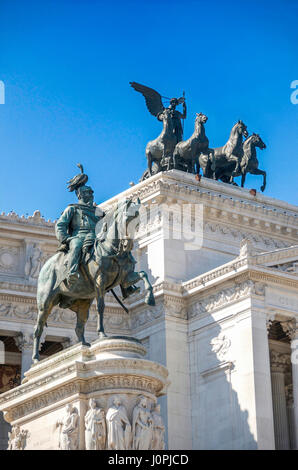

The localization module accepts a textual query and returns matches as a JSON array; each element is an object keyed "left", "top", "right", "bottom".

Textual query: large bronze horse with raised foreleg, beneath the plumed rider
[{"left": 33, "top": 200, "right": 155, "bottom": 362}]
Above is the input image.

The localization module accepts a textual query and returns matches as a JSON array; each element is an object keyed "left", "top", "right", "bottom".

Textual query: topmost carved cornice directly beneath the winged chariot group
[{"left": 102, "top": 170, "right": 298, "bottom": 236}]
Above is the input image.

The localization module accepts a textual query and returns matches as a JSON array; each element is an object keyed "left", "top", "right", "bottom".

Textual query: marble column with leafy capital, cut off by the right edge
[{"left": 282, "top": 319, "right": 298, "bottom": 450}]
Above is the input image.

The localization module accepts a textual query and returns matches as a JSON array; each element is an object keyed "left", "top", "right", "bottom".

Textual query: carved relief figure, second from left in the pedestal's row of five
[{"left": 85, "top": 398, "right": 106, "bottom": 450}]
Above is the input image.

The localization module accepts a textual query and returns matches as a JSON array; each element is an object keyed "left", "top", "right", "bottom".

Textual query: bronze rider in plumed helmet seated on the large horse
[{"left": 56, "top": 163, "right": 104, "bottom": 285}]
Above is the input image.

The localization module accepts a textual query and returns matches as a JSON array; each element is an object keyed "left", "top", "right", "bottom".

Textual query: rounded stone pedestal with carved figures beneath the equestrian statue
[{"left": 0, "top": 337, "right": 168, "bottom": 450}]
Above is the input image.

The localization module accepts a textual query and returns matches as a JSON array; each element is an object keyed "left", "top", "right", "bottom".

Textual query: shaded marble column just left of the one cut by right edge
[{"left": 270, "top": 350, "right": 290, "bottom": 450}]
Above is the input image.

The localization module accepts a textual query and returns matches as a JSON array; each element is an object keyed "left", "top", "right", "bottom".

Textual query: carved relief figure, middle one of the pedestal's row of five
[{"left": 106, "top": 396, "right": 131, "bottom": 450}]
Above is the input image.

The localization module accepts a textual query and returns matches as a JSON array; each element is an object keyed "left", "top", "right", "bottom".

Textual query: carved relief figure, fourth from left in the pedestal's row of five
[{"left": 132, "top": 396, "right": 153, "bottom": 450}]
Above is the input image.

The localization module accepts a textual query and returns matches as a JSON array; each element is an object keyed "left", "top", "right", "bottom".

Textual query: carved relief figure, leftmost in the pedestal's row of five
[{"left": 57, "top": 403, "right": 79, "bottom": 450}]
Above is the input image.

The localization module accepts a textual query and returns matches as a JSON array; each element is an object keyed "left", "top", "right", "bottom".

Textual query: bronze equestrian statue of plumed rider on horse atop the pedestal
[{"left": 33, "top": 167, "right": 155, "bottom": 362}]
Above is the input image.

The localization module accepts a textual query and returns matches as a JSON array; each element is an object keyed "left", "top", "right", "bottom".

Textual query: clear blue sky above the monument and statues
[{"left": 0, "top": 0, "right": 298, "bottom": 219}]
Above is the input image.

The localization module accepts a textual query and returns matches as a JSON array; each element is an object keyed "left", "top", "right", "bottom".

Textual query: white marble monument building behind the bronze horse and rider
[{"left": 0, "top": 170, "right": 298, "bottom": 449}]
